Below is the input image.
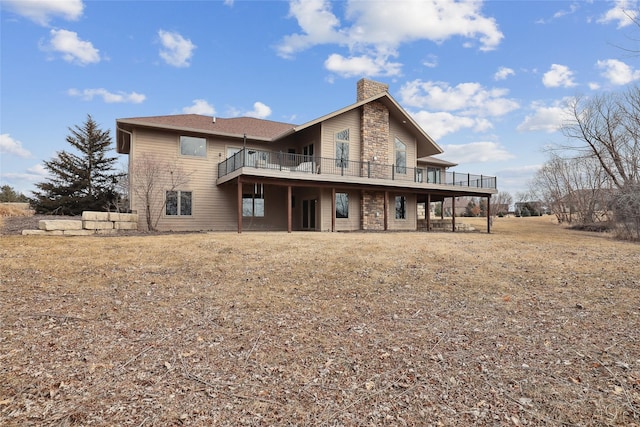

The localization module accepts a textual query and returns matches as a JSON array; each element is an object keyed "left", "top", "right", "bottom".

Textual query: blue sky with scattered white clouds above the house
[{"left": 0, "top": 0, "right": 640, "bottom": 196}]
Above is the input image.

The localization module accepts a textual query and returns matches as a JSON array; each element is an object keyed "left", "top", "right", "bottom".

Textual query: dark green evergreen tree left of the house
[{"left": 33, "top": 115, "right": 120, "bottom": 215}]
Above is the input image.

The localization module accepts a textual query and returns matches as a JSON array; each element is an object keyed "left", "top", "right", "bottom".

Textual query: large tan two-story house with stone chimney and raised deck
[{"left": 116, "top": 79, "right": 497, "bottom": 232}]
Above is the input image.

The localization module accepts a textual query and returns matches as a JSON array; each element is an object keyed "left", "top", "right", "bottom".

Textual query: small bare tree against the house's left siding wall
[{"left": 130, "top": 155, "right": 190, "bottom": 231}]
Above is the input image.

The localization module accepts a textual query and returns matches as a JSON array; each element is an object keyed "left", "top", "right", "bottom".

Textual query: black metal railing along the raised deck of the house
[{"left": 218, "top": 149, "right": 497, "bottom": 189}]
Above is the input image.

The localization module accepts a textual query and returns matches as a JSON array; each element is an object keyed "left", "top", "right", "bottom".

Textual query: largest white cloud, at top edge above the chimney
[{"left": 277, "top": 0, "right": 503, "bottom": 76}]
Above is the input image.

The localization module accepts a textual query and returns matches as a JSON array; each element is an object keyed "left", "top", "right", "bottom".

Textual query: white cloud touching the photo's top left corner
[{"left": 2, "top": 0, "right": 84, "bottom": 26}]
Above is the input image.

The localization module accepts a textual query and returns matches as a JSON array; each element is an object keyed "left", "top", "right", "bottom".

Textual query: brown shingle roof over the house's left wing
[{"left": 117, "top": 114, "right": 294, "bottom": 139}]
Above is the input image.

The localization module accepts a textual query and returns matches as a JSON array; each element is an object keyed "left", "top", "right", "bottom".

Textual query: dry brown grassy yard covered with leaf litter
[{"left": 0, "top": 217, "right": 640, "bottom": 426}]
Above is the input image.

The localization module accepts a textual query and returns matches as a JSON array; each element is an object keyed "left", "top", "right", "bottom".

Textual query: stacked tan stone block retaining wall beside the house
[{"left": 22, "top": 211, "right": 138, "bottom": 236}]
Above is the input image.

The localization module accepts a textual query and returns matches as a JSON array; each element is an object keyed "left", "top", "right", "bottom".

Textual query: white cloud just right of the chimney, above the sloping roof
[{"left": 400, "top": 80, "right": 519, "bottom": 116}]
